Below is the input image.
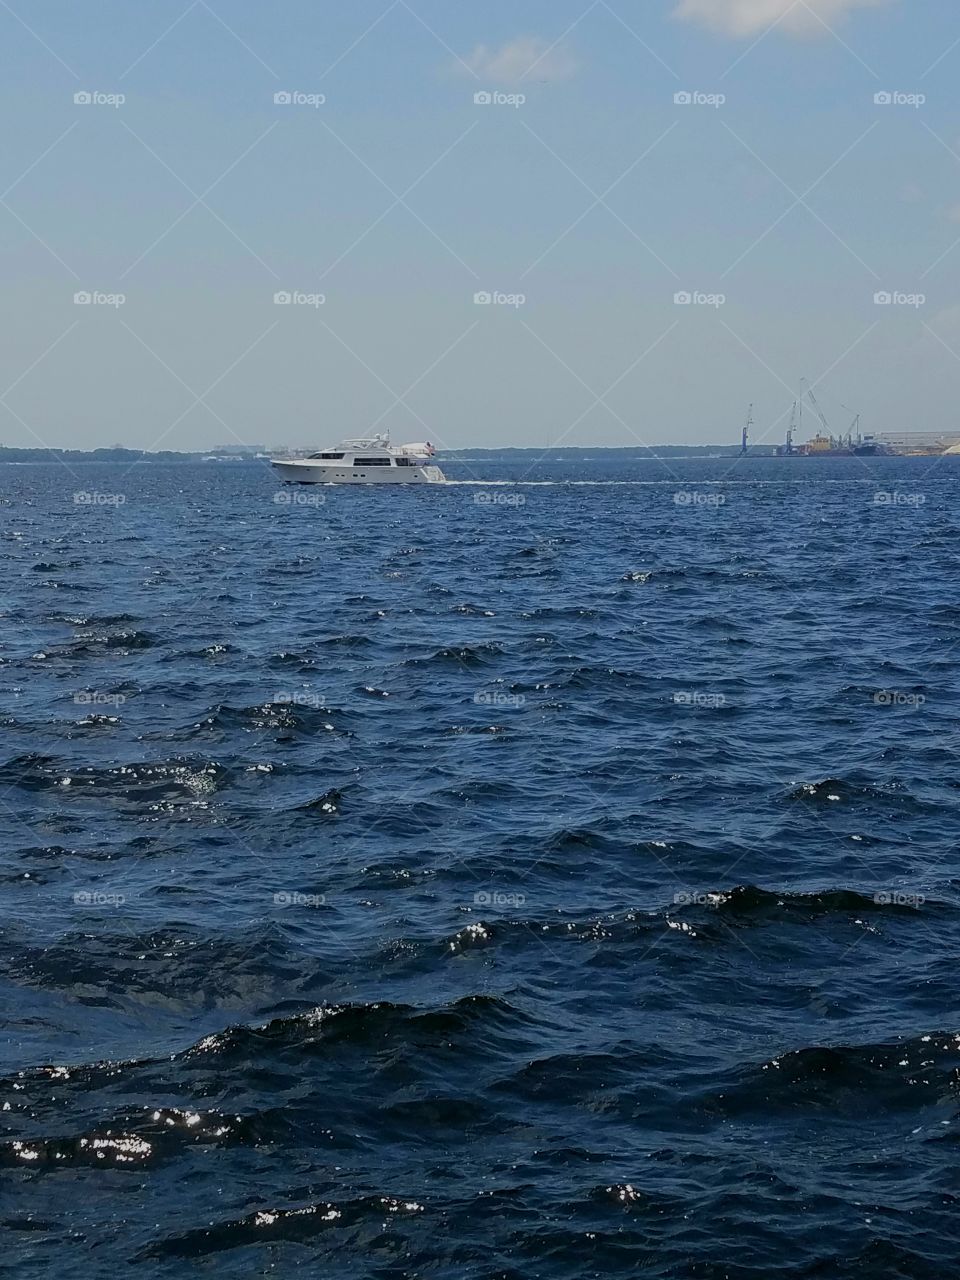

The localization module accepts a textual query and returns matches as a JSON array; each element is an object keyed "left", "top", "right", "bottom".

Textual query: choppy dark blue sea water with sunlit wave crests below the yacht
[{"left": 0, "top": 452, "right": 960, "bottom": 1280}]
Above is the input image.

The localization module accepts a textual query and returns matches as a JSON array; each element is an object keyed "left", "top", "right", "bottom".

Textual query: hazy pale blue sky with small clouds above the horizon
[{"left": 0, "top": 0, "right": 960, "bottom": 449}]
